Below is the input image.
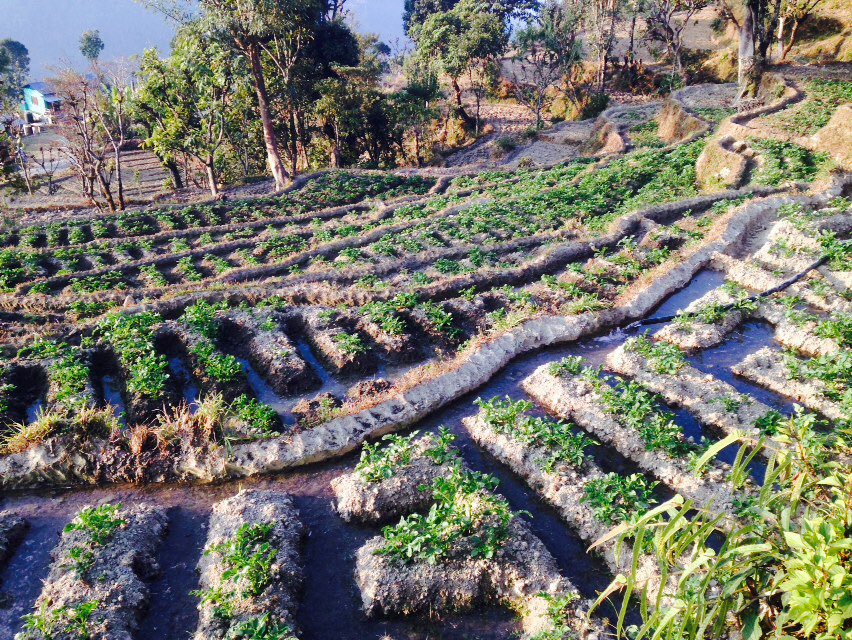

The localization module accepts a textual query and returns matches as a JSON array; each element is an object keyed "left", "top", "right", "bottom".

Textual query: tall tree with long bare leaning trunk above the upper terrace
[{"left": 201, "top": 0, "right": 328, "bottom": 190}]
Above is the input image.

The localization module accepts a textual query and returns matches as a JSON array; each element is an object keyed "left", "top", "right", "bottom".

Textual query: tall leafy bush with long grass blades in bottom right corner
[{"left": 596, "top": 413, "right": 852, "bottom": 640}]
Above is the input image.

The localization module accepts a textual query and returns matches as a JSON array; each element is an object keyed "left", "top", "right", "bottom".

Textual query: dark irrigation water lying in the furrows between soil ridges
[{"left": 0, "top": 270, "right": 792, "bottom": 640}]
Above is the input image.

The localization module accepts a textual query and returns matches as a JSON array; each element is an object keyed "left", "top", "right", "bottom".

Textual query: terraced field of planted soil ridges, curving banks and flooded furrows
[{"left": 0, "top": 75, "right": 852, "bottom": 640}]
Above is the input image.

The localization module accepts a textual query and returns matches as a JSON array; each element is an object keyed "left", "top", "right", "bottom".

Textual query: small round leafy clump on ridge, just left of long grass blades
[{"left": 583, "top": 473, "right": 659, "bottom": 524}]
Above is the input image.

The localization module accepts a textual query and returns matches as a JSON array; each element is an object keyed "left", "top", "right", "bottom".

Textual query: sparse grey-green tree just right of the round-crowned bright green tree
[{"left": 512, "top": 0, "right": 582, "bottom": 129}]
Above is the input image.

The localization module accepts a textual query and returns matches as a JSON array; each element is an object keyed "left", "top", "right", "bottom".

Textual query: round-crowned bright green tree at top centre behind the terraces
[{"left": 416, "top": 0, "right": 509, "bottom": 127}]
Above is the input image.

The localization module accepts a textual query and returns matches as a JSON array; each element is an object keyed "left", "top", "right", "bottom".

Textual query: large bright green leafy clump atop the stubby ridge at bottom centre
[{"left": 376, "top": 466, "right": 515, "bottom": 564}]
